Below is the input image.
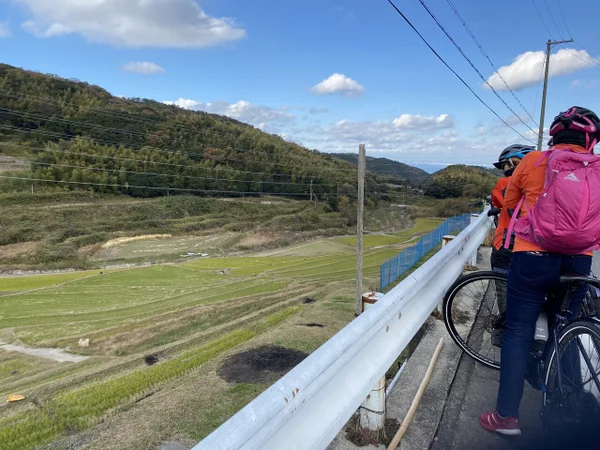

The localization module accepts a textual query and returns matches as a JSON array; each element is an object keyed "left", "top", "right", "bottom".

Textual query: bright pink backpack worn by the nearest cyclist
[{"left": 505, "top": 149, "right": 600, "bottom": 255}]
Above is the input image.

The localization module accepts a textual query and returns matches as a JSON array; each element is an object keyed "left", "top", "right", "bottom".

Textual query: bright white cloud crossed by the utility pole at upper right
[{"left": 484, "top": 48, "right": 600, "bottom": 91}]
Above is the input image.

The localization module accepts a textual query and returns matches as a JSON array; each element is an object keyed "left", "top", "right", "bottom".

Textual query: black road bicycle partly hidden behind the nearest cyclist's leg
[{"left": 443, "top": 271, "right": 600, "bottom": 431}]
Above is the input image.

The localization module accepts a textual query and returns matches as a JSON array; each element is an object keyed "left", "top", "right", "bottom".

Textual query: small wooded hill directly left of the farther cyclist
[{"left": 425, "top": 164, "right": 501, "bottom": 198}]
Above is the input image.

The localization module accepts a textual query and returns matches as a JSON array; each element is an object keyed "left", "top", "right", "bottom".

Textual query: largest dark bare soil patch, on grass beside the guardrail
[{"left": 218, "top": 345, "right": 308, "bottom": 384}]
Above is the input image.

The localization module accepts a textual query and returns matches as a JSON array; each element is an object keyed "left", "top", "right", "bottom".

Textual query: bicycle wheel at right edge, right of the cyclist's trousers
[{"left": 540, "top": 320, "right": 600, "bottom": 436}]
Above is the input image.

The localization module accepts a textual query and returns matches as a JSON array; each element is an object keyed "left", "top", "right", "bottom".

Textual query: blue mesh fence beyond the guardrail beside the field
[{"left": 379, "top": 214, "right": 471, "bottom": 291}]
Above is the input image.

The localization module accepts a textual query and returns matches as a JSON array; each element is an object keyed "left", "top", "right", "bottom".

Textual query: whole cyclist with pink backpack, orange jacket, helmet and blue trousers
[{"left": 480, "top": 106, "right": 600, "bottom": 435}]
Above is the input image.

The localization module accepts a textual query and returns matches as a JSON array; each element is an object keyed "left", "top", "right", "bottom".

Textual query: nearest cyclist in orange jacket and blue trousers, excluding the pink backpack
[{"left": 479, "top": 106, "right": 600, "bottom": 436}]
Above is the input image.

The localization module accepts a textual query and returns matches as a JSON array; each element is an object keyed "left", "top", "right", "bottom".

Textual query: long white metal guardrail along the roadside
[{"left": 193, "top": 211, "right": 491, "bottom": 450}]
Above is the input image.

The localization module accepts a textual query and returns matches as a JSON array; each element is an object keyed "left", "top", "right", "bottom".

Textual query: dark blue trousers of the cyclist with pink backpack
[{"left": 496, "top": 252, "right": 592, "bottom": 417}]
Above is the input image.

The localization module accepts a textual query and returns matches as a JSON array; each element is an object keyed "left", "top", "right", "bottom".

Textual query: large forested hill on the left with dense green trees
[{"left": 0, "top": 64, "right": 387, "bottom": 198}]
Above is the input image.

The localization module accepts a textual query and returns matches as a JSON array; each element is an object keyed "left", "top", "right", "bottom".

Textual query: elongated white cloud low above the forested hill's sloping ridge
[{"left": 164, "top": 98, "right": 294, "bottom": 127}]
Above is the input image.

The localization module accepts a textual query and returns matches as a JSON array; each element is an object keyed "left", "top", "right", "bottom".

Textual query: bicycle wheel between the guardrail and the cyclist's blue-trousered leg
[{"left": 442, "top": 271, "right": 506, "bottom": 369}]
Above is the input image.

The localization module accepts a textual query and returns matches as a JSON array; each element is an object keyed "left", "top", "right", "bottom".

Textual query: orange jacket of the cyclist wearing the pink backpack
[{"left": 504, "top": 144, "right": 591, "bottom": 254}]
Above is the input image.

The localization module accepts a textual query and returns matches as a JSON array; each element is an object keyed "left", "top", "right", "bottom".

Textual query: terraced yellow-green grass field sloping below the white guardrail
[{"left": 0, "top": 216, "right": 446, "bottom": 450}]
